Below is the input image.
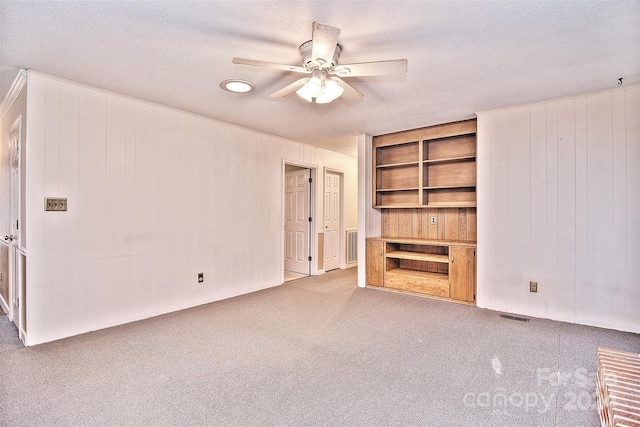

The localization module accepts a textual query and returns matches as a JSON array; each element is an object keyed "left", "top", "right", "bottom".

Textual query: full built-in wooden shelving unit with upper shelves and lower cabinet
[{"left": 366, "top": 120, "right": 477, "bottom": 305}]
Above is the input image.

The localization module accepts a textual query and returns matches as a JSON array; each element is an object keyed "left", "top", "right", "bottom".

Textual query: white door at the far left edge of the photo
[{"left": 4, "top": 117, "right": 24, "bottom": 331}]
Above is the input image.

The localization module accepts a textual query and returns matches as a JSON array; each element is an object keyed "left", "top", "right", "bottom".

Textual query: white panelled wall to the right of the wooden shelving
[{"left": 477, "top": 86, "right": 640, "bottom": 332}]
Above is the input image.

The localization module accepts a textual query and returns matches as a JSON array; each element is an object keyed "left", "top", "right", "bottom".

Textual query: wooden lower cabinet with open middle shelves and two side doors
[{"left": 366, "top": 238, "right": 476, "bottom": 304}]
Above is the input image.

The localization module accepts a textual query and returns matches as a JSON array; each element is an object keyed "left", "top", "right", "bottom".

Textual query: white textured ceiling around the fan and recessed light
[{"left": 0, "top": 0, "right": 640, "bottom": 155}]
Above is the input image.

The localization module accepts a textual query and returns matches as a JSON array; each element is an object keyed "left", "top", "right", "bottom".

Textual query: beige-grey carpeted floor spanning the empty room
[{"left": 0, "top": 268, "right": 640, "bottom": 426}]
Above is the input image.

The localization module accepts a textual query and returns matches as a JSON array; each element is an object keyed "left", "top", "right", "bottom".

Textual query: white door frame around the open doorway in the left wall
[{"left": 280, "top": 157, "right": 318, "bottom": 283}]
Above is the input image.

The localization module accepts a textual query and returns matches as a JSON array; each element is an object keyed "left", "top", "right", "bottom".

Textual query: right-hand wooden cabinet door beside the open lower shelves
[{"left": 449, "top": 246, "right": 476, "bottom": 302}]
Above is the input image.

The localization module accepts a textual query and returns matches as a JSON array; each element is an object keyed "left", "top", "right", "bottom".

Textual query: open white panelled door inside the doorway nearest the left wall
[{"left": 284, "top": 169, "right": 311, "bottom": 274}]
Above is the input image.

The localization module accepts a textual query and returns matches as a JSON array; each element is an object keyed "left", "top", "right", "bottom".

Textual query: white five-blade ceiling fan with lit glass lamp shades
[{"left": 232, "top": 22, "right": 407, "bottom": 104}]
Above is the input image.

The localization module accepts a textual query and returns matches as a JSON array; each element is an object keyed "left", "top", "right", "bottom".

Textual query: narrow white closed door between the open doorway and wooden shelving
[{"left": 324, "top": 171, "right": 341, "bottom": 271}]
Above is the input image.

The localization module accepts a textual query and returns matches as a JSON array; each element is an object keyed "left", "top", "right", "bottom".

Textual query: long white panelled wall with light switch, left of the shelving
[{"left": 26, "top": 72, "right": 357, "bottom": 345}]
